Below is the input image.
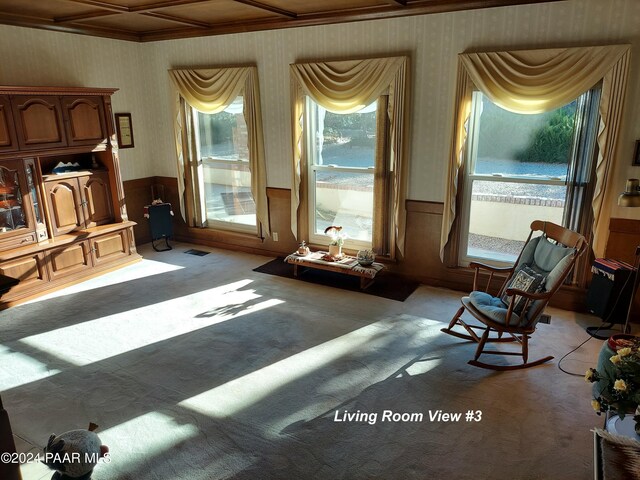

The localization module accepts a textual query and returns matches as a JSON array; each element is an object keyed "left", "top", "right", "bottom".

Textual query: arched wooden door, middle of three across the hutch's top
[{"left": 11, "top": 95, "right": 67, "bottom": 150}]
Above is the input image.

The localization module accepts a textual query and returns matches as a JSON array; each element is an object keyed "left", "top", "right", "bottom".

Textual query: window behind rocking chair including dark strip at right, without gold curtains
[{"left": 460, "top": 90, "right": 599, "bottom": 264}]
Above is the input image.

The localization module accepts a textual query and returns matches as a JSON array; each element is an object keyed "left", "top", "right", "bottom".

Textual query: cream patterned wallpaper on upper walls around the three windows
[{"left": 0, "top": 0, "right": 640, "bottom": 218}]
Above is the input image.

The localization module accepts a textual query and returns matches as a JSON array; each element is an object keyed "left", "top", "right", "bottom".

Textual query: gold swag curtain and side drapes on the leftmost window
[{"left": 169, "top": 67, "right": 270, "bottom": 235}]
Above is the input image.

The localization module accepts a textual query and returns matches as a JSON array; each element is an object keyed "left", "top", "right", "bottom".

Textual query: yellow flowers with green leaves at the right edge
[{"left": 584, "top": 335, "right": 640, "bottom": 435}]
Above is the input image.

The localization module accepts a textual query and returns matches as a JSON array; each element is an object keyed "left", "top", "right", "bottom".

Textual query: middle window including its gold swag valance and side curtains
[{"left": 290, "top": 57, "right": 408, "bottom": 258}]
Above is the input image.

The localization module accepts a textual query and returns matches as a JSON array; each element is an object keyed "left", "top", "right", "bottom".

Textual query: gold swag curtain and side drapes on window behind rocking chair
[{"left": 440, "top": 45, "right": 630, "bottom": 264}]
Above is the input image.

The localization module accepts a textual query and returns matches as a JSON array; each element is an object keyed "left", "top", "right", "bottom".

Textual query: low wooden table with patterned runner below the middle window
[{"left": 284, "top": 252, "right": 384, "bottom": 290}]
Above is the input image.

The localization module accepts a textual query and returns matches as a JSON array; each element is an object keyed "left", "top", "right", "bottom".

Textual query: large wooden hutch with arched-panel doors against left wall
[{"left": 0, "top": 86, "right": 140, "bottom": 309}]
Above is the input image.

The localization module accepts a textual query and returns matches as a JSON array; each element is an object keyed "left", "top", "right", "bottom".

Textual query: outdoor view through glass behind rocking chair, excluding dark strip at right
[{"left": 464, "top": 92, "right": 577, "bottom": 262}]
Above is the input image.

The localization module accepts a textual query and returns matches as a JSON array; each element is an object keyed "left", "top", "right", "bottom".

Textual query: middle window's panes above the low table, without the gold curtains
[{"left": 306, "top": 97, "right": 385, "bottom": 248}]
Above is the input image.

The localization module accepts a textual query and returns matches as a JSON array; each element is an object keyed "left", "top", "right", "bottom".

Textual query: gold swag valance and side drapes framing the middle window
[{"left": 290, "top": 57, "right": 409, "bottom": 256}]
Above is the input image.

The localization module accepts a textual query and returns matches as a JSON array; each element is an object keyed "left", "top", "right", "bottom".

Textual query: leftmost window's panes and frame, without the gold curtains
[{"left": 193, "top": 96, "right": 256, "bottom": 231}]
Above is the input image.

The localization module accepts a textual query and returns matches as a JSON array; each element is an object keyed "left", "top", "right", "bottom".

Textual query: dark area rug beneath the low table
[{"left": 253, "top": 257, "right": 420, "bottom": 302}]
